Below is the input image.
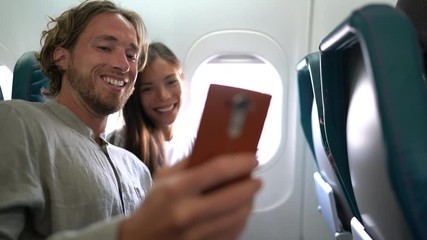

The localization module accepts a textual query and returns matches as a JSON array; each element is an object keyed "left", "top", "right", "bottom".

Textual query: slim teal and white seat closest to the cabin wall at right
[{"left": 296, "top": 52, "right": 354, "bottom": 240}]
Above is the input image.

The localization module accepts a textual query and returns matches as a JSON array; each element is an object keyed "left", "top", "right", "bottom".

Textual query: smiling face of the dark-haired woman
[{"left": 139, "top": 58, "right": 183, "bottom": 127}]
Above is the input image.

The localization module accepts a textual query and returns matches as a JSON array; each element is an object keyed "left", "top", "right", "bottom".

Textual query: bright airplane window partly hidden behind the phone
[{"left": 190, "top": 54, "right": 283, "bottom": 165}]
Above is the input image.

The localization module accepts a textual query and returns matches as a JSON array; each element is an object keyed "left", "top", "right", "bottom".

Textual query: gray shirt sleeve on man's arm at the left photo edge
[{"left": 0, "top": 105, "right": 44, "bottom": 239}]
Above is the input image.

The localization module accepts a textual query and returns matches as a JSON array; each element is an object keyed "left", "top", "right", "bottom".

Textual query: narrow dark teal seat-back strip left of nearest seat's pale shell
[{"left": 319, "top": 34, "right": 361, "bottom": 227}]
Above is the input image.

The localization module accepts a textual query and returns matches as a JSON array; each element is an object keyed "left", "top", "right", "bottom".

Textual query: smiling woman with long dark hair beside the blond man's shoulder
[{"left": 109, "top": 42, "right": 192, "bottom": 175}]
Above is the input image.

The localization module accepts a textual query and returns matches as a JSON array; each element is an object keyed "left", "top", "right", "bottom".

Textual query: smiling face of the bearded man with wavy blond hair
[{"left": 61, "top": 13, "right": 140, "bottom": 116}]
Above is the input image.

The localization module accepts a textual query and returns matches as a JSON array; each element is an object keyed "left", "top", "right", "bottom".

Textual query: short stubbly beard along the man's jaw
[{"left": 66, "top": 67, "right": 132, "bottom": 116}]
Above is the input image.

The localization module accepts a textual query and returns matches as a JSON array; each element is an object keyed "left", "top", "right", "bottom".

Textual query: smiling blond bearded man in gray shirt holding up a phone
[{"left": 0, "top": 1, "right": 260, "bottom": 240}]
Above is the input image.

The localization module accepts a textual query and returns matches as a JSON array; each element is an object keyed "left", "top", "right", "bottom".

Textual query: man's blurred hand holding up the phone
[{"left": 120, "top": 153, "right": 261, "bottom": 240}]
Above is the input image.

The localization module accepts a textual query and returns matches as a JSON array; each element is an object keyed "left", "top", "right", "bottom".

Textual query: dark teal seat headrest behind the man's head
[{"left": 12, "top": 51, "right": 49, "bottom": 102}]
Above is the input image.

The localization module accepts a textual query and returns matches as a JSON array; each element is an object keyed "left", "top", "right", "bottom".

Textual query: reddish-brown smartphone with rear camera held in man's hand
[{"left": 189, "top": 84, "right": 271, "bottom": 166}]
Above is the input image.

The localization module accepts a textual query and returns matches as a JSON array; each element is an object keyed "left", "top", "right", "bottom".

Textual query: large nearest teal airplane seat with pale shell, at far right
[{"left": 319, "top": 4, "right": 427, "bottom": 240}]
